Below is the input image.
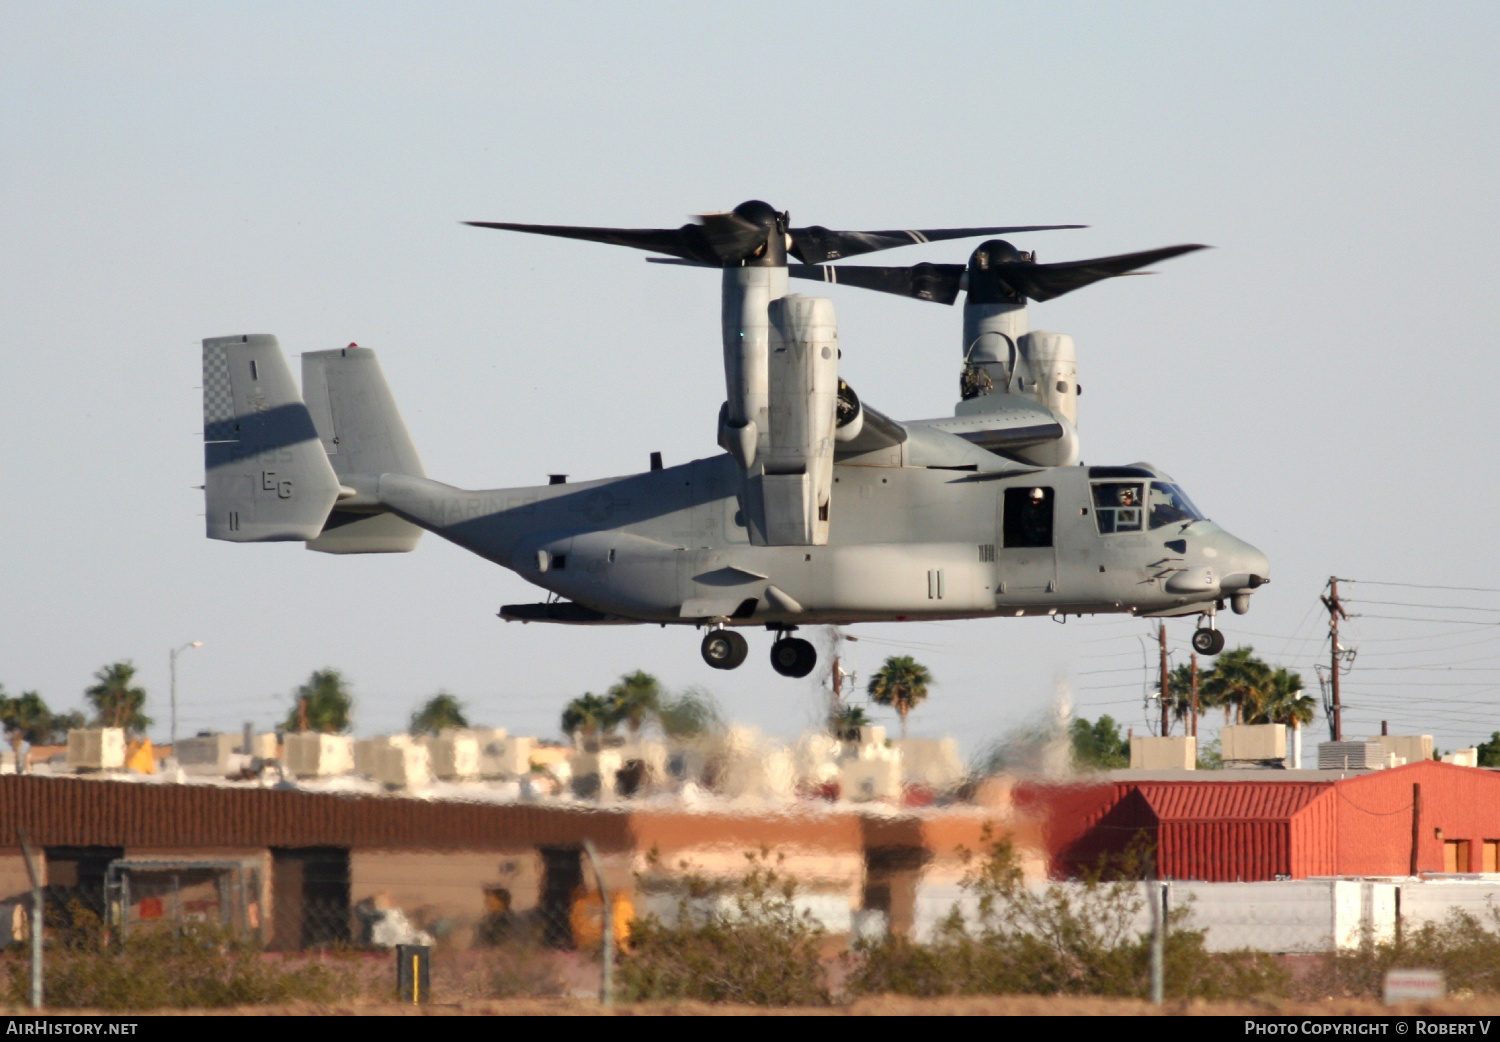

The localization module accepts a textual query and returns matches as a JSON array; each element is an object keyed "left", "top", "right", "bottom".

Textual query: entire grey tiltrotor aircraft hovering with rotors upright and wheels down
[{"left": 203, "top": 202, "right": 1269, "bottom": 676}]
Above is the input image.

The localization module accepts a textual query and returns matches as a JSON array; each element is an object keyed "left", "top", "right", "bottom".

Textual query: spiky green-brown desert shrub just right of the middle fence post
[{"left": 620, "top": 850, "right": 830, "bottom": 1006}]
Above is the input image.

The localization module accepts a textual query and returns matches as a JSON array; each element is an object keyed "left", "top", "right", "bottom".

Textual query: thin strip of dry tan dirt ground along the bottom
[{"left": 5, "top": 996, "right": 1500, "bottom": 1017}]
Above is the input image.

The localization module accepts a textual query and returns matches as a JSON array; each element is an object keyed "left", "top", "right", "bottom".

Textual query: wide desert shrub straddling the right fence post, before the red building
[{"left": 848, "top": 841, "right": 1287, "bottom": 999}]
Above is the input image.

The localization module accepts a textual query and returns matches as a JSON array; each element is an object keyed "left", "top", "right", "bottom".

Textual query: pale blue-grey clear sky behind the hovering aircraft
[{"left": 0, "top": 3, "right": 1500, "bottom": 750}]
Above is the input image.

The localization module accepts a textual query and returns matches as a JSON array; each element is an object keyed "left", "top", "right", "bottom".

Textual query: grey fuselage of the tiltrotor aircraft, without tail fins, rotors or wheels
[{"left": 354, "top": 450, "right": 1269, "bottom": 627}]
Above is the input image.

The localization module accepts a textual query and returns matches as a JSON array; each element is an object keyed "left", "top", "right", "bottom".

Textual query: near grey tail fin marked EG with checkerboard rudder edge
[{"left": 203, "top": 334, "right": 339, "bottom": 543}]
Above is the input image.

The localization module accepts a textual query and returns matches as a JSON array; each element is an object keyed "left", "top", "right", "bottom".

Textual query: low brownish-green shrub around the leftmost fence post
[{"left": 6, "top": 907, "right": 347, "bottom": 1009}]
